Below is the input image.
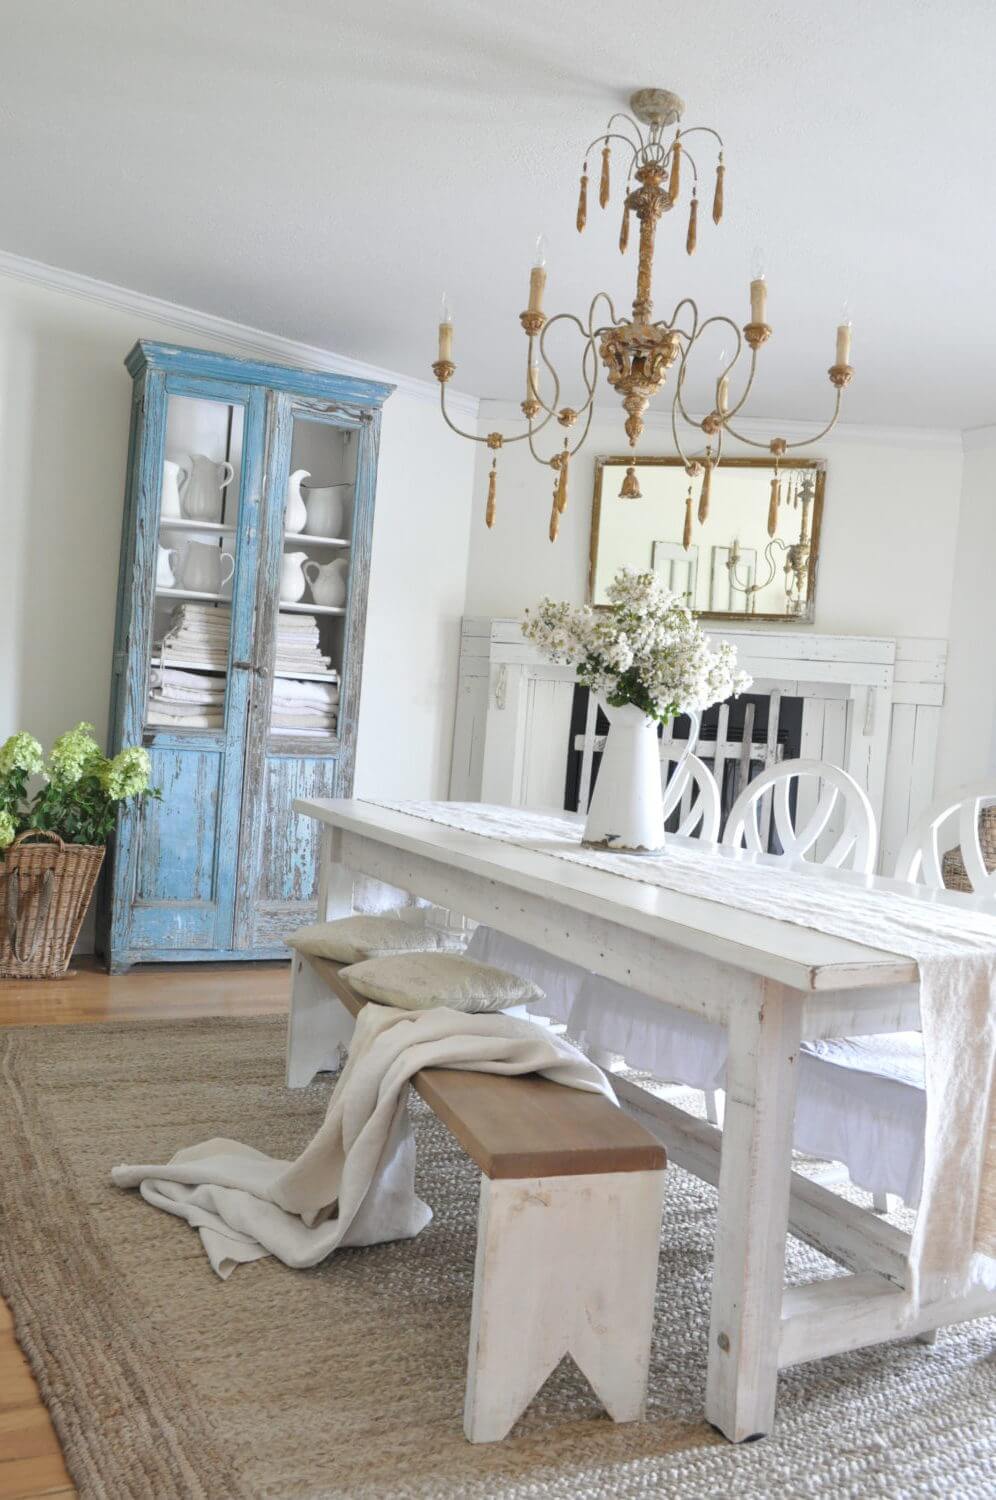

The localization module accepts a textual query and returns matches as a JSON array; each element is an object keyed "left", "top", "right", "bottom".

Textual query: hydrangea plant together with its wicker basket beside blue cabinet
[{"left": 0, "top": 725, "right": 159, "bottom": 980}]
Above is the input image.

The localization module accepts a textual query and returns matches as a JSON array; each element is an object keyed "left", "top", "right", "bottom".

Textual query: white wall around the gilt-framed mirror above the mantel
[{"left": 467, "top": 402, "right": 962, "bottom": 636}]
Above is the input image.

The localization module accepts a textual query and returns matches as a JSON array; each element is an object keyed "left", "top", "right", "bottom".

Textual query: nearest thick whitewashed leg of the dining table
[{"left": 705, "top": 980, "right": 803, "bottom": 1443}]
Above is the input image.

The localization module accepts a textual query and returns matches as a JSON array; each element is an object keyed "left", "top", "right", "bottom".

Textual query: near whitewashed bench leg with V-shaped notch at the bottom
[{"left": 464, "top": 1172, "right": 665, "bottom": 1443}]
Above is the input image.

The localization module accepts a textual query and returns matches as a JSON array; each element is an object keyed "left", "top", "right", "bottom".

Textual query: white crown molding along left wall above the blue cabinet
[{"left": 0, "top": 251, "right": 480, "bottom": 420}]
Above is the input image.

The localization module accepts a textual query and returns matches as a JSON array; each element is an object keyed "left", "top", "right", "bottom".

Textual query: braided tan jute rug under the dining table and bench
[{"left": 0, "top": 1020, "right": 996, "bottom": 1500}]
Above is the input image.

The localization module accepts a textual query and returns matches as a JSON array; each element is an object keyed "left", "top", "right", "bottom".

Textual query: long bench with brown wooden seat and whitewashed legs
[{"left": 294, "top": 954, "right": 666, "bottom": 1443}]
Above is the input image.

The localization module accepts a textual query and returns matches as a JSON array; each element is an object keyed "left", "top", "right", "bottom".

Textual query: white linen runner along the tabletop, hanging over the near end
[{"left": 375, "top": 801, "right": 996, "bottom": 1308}]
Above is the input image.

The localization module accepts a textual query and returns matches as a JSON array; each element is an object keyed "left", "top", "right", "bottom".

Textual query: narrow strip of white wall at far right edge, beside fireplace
[{"left": 936, "top": 428, "right": 996, "bottom": 791}]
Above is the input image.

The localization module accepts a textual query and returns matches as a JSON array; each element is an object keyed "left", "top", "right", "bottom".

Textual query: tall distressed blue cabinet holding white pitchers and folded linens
[{"left": 99, "top": 341, "right": 392, "bottom": 971}]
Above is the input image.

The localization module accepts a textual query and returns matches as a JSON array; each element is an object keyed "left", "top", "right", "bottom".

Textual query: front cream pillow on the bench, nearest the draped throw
[{"left": 342, "top": 953, "right": 545, "bottom": 1011}]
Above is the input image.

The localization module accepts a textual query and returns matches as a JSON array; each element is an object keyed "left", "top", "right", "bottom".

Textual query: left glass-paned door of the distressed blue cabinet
[{"left": 120, "top": 375, "right": 266, "bottom": 950}]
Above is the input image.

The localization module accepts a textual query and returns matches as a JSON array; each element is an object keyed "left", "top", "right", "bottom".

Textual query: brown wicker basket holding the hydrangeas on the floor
[{"left": 0, "top": 830, "right": 104, "bottom": 980}]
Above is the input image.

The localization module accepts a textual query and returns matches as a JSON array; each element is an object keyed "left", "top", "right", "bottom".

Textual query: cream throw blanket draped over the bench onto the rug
[{"left": 111, "top": 996, "right": 615, "bottom": 1277}]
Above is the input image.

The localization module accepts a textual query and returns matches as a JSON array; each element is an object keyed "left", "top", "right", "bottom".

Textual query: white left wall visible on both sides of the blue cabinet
[{"left": 0, "top": 262, "right": 474, "bottom": 797}]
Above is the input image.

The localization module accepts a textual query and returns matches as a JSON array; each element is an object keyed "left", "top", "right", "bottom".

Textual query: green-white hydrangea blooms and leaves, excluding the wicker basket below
[{"left": 0, "top": 723, "right": 161, "bottom": 849}]
